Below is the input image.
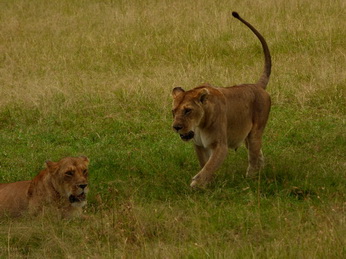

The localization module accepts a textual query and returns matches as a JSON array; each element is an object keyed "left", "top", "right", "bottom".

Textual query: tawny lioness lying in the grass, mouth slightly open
[{"left": 0, "top": 156, "right": 89, "bottom": 218}]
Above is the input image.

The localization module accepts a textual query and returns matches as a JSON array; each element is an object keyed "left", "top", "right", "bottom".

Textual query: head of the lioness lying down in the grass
[{"left": 46, "top": 156, "right": 89, "bottom": 207}]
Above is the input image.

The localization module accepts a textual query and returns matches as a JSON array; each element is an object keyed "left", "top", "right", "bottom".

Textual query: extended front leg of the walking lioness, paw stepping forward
[{"left": 190, "top": 145, "right": 228, "bottom": 187}]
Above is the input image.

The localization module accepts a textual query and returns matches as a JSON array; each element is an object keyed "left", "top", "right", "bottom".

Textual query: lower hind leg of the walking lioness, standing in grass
[{"left": 245, "top": 134, "right": 264, "bottom": 177}]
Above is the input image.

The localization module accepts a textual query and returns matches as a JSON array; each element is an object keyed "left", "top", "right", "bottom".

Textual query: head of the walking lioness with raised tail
[{"left": 172, "top": 86, "right": 209, "bottom": 141}]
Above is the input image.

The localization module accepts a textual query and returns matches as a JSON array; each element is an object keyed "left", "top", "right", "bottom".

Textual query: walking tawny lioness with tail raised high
[{"left": 172, "top": 12, "right": 271, "bottom": 187}]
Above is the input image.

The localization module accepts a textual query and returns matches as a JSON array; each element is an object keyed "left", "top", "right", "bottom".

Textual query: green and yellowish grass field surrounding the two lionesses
[{"left": 0, "top": 0, "right": 346, "bottom": 258}]
